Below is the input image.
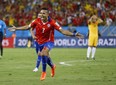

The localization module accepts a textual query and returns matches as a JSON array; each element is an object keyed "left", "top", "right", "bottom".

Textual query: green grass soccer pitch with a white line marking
[{"left": 0, "top": 48, "right": 116, "bottom": 85}]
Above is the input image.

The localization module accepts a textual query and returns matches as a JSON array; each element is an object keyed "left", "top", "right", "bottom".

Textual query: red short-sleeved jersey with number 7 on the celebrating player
[{"left": 30, "top": 18, "right": 61, "bottom": 44}]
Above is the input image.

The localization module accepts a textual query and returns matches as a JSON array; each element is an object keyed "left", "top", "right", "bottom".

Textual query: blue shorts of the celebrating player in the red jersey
[{"left": 35, "top": 41, "right": 54, "bottom": 53}]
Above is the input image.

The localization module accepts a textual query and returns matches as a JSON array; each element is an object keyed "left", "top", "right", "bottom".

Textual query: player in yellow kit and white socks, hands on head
[{"left": 87, "top": 15, "right": 103, "bottom": 60}]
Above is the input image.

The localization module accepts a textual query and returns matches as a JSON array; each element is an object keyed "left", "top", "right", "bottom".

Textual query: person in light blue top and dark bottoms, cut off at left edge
[{"left": 0, "top": 19, "right": 6, "bottom": 58}]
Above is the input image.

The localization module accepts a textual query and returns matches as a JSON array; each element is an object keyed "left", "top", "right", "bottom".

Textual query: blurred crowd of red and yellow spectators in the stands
[{"left": 0, "top": 0, "right": 116, "bottom": 26}]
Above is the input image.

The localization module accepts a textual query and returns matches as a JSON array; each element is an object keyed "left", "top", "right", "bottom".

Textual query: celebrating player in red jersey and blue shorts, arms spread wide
[{"left": 8, "top": 8, "right": 83, "bottom": 80}]
